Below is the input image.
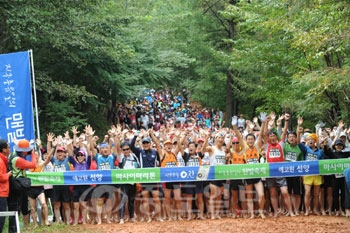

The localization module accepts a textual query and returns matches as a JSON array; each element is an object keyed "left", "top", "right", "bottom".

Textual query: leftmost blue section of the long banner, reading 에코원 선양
[{"left": 63, "top": 170, "right": 113, "bottom": 185}]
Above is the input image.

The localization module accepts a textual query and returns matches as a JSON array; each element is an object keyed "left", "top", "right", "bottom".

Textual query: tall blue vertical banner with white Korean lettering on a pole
[{"left": 0, "top": 51, "right": 35, "bottom": 147}]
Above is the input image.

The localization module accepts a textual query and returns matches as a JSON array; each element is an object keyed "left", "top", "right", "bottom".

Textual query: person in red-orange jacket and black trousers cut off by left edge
[{"left": 0, "top": 139, "right": 12, "bottom": 232}]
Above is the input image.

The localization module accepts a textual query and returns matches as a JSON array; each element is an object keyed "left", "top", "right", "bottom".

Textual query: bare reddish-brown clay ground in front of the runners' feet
[{"left": 69, "top": 215, "right": 350, "bottom": 233}]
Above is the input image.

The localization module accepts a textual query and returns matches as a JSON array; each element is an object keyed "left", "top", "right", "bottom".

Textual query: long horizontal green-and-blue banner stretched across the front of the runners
[{"left": 27, "top": 159, "right": 350, "bottom": 185}]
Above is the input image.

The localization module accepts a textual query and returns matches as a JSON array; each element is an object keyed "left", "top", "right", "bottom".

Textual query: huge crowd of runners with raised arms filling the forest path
[{"left": 0, "top": 89, "right": 350, "bottom": 232}]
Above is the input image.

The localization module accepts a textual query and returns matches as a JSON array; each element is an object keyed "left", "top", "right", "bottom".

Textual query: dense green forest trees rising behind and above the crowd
[{"left": 0, "top": 0, "right": 350, "bottom": 137}]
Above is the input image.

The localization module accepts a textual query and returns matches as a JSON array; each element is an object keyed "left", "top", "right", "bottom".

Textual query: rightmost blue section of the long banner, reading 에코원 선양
[{"left": 269, "top": 161, "right": 320, "bottom": 177}]
